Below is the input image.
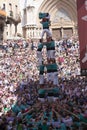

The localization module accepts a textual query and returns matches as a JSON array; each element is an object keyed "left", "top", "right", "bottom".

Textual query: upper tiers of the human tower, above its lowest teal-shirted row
[{"left": 37, "top": 13, "right": 58, "bottom": 86}]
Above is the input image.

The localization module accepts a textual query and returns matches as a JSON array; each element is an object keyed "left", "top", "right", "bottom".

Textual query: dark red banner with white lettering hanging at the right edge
[{"left": 77, "top": 0, "right": 87, "bottom": 76}]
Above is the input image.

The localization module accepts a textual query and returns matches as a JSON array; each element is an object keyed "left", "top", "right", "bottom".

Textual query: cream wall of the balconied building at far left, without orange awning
[{"left": 0, "top": 0, "right": 22, "bottom": 40}]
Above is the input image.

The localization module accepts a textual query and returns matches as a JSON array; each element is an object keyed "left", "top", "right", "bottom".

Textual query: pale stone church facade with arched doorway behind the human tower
[{"left": 22, "top": 0, "right": 77, "bottom": 40}]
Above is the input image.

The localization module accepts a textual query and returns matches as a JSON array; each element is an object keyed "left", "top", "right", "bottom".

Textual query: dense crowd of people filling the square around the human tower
[{"left": 0, "top": 39, "right": 87, "bottom": 130}]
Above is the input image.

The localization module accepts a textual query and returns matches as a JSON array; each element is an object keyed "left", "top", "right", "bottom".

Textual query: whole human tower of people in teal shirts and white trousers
[{"left": 37, "top": 13, "right": 59, "bottom": 101}]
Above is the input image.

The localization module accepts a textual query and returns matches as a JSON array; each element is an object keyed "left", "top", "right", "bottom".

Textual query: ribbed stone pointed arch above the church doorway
[{"left": 37, "top": 0, "right": 77, "bottom": 39}]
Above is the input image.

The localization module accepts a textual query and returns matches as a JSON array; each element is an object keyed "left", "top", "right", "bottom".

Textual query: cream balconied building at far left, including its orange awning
[{"left": 0, "top": 0, "right": 21, "bottom": 41}]
